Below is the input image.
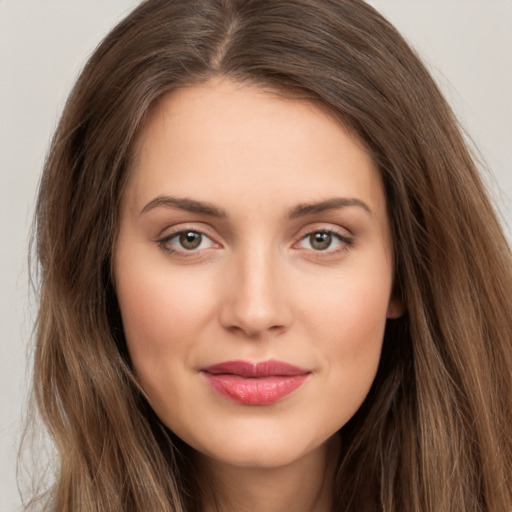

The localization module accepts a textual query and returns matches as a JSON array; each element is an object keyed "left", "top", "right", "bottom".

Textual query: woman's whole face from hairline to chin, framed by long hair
[{"left": 115, "top": 80, "right": 400, "bottom": 467}]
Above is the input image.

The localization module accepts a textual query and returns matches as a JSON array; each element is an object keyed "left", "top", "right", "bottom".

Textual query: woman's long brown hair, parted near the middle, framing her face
[{"left": 29, "top": 0, "right": 512, "bottom": 512}]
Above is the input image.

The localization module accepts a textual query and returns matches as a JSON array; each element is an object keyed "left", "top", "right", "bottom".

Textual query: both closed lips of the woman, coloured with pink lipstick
[{"left": 201, "top": 360, "right": 311, "bottom": 405}]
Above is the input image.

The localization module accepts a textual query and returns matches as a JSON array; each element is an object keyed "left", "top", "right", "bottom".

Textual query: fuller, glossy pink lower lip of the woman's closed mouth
[{"left": 204, "top": 372, "right": 309, "bottom": 405}]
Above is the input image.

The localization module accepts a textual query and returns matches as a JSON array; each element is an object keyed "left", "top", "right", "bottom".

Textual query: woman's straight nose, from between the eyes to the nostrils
[{"left": 220, "top": 246, "right": 291, "bottom": 339}]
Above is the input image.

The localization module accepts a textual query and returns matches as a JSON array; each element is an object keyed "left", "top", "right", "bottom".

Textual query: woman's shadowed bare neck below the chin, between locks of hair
[{"left": 198, "top": 438, "right": 339, "bottom": 512}]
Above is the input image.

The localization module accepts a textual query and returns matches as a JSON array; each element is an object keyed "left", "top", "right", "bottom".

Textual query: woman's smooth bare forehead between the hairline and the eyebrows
[{"left": 127, "top": 79, "right": 384, "bottom": 219}]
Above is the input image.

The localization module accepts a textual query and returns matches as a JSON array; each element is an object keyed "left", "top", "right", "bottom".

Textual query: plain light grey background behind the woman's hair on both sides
[{"left": 0, "top": 0, "right": 512, "bottom": 512}]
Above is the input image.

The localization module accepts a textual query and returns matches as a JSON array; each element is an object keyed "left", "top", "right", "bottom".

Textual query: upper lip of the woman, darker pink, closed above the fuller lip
[{"left": 201, "top": 359, "right": 311, "bottom": 378}]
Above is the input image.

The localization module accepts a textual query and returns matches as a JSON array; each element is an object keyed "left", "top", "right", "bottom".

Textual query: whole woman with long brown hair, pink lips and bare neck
[{"left": 30, "top": 0, "right": 512, "bottom": 512}]
